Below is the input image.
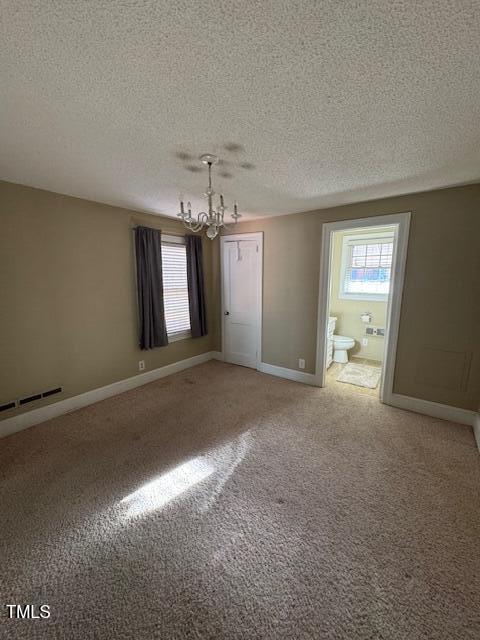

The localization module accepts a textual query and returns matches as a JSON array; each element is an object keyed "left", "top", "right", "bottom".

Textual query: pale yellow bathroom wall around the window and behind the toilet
[{"left": 330, "top": 227, "right": 393, "bottom": 361}]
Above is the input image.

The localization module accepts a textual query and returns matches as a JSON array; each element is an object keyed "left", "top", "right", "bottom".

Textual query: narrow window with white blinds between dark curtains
[{"left": 162, "top": 235, "right": 191, "bottom": 341}]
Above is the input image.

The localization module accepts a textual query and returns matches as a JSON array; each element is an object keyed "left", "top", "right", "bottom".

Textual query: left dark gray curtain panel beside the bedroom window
[{"left": 135, "top": 227, "right": 168, "bottom": 349}]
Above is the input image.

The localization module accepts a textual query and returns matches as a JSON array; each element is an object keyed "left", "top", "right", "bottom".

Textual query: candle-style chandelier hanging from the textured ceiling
[{"left": 177, "top": 153, "right": 242, "bottom": 240}]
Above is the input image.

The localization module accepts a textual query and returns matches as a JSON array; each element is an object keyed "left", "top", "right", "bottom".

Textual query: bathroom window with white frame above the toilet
[{"left": 339, "top": 231, "right": 394, "bottom": 301}]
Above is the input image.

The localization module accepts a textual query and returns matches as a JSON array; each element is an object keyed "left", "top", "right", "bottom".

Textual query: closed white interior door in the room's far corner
[{"left": 222, "top": 234, "right": 262, "bottom": 369}]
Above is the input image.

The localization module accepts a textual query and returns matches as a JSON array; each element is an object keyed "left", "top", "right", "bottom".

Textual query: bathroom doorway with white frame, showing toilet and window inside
[{"left": 317, "top": 213, "right": 410, "bottom": 403}]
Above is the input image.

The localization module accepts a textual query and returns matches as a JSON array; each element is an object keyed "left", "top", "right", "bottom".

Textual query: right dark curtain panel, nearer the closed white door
[{"left": 185, "top": 236, "right": 208, "bottom": 338}]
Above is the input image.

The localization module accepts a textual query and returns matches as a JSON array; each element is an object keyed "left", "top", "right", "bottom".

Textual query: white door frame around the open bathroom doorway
[{"left": 315, "top": 212, "right": 410, "bottom": 404}]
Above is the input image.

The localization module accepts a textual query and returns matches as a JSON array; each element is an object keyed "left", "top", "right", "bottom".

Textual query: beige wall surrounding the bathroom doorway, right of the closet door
[{"left": 224, "top": 184, "right": 480, "bottom": 410}]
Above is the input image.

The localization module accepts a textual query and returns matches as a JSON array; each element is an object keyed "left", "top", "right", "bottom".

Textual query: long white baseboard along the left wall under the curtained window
[{"left": 0, "top": 351, "right": 218, "bottom": 438}]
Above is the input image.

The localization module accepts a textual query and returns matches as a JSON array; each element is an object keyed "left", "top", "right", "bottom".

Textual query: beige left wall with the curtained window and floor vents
[{"left": 0, "top": 182, "right": 219, "bottom": 419}]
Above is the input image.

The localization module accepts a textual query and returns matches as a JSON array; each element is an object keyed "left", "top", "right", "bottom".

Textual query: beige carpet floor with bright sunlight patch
[{"left": 0, "top": 362, "right": 480, "bottom": 640}]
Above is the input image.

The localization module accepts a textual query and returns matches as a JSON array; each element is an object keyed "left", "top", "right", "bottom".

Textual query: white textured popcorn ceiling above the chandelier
[{"left": 0, "top": 0, "right": 480, "bottom": 217}]
